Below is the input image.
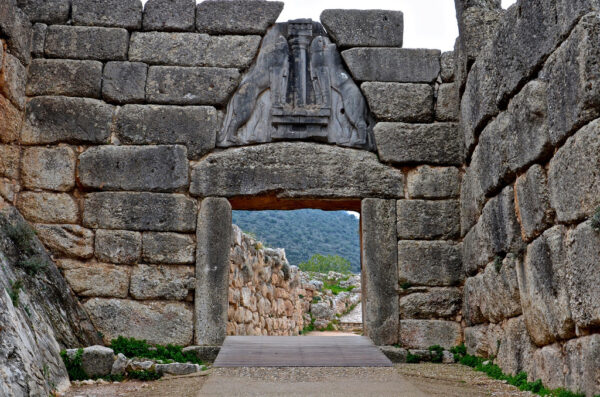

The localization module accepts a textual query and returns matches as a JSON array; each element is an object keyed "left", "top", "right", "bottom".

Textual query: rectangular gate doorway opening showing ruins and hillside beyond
[{"left": 227, "top": 209, "right": 363, "bottom": 336}]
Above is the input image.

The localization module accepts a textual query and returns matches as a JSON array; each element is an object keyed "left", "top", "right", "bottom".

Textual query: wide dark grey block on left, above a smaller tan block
[{"left": 21, "top": 97, "right": 114, "bottom": 144}]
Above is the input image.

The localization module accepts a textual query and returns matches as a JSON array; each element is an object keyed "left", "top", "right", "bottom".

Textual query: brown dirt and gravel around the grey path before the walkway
[{"left": 66, "top": 363, "right": 532, "bottom": 397}]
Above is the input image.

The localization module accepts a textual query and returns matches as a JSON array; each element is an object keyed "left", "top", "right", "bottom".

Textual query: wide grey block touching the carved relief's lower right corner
[{"left": 374, "top": 123, "right": 463, "bottom": 165}]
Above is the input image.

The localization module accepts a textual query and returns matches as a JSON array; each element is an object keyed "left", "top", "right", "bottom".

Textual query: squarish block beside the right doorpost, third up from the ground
[{"left": 398, "top": 241, "right": 463, "bottom": 287}]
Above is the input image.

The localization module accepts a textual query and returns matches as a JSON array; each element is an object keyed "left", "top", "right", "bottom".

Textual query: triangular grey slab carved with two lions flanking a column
[{"left": 217, "top": 19, "right": 374, "bottom": 150}]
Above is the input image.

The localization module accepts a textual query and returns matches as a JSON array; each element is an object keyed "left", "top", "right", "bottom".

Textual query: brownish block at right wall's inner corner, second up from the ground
[{"left": 463, "top": 254, "right": 522, "bottom": 325}]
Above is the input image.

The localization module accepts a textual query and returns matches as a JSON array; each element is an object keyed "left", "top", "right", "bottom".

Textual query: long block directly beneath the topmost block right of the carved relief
[{"left": 342, "top": 49, "right": 440, "bottom": 83}]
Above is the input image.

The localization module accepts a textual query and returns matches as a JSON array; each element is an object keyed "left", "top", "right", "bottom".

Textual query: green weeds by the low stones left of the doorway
[{"left": 110, "top": 336, "right": 203, "bottom": 365}]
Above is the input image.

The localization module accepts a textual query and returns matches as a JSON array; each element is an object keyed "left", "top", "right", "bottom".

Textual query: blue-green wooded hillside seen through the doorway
[{"left": 233, "top": 209, "right": 360, "bottom": 273}]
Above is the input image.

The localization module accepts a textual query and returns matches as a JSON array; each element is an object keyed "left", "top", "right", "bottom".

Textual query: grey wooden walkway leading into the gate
[{"left": 213, "top": 336, "right": 392, "bottom": 367}]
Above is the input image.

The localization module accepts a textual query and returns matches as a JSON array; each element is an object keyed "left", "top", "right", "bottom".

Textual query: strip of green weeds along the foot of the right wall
[{"left": 450, "top": 344, "right": 585, "bottom": 397}]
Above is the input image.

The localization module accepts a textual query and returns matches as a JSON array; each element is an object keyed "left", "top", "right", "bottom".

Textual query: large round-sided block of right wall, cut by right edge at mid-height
[{"left": 548, "top": 120, "right": 600, "bottom": 222}]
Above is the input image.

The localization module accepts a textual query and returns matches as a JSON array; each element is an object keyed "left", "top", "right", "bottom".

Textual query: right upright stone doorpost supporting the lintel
[{"left": 361, "top": 199, "right": 400, "bottom": 345}]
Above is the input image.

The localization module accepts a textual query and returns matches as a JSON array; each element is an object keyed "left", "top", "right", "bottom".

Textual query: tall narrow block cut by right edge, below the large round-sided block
[{"left": 567, "top": 221, "right": 600, "bottom": 329}]
